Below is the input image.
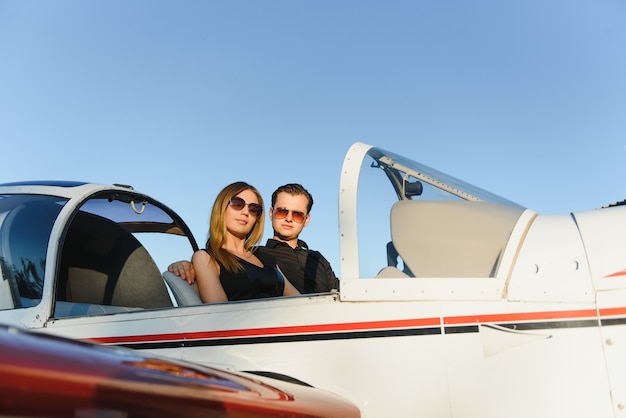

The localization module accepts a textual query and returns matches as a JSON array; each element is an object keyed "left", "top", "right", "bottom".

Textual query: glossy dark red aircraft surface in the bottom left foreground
[{"left": 0, "top": 325, "right": 360, "bottom": 418}]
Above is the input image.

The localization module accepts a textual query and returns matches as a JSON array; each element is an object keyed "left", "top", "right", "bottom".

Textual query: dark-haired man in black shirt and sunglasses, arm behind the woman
[{"left": 168, "top": 183, "right": 339, "bottom": 293}]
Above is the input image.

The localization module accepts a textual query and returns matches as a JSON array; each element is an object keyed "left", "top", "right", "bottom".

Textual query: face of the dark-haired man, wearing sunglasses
[{"left": 269, "top": 192, "right": 310, "bottom": 241}]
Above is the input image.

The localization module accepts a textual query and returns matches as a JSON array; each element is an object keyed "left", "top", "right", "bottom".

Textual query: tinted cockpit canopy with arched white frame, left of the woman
[{"left": 0, "top": 182, "right": 197, "bottom": 316}]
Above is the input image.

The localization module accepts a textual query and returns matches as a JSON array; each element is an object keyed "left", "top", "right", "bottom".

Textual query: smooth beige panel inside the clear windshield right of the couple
[{"left": 391, "top": 200, "right": 524, "bottom": 277}]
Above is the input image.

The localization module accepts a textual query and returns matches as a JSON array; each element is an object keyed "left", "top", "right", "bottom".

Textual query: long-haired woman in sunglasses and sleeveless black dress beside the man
[{"left": 191, "top": 182, "right": 300, "bottom": 303}]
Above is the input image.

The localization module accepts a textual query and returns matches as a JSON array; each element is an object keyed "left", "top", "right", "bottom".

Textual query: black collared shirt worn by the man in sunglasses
[{"left": 257, "top": 238, "right": 339, "bottom": 293}]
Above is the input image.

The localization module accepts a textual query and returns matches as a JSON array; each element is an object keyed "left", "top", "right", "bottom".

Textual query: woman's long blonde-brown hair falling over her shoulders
[{"left": 206, "top": 181, "right": 265, "bottom": 271}]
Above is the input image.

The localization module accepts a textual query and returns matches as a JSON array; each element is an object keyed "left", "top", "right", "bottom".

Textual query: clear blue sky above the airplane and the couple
[{"left": 0, "top": 0, "right": 626, "bottom": 271}]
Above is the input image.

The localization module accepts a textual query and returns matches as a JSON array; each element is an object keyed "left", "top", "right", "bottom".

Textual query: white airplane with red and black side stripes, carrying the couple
[{"left": 0, "top": 142, "right": 626, "bottom": 418}]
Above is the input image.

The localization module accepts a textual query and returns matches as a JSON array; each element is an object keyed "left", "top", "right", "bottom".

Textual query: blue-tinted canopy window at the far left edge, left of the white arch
[{"left": 0, "top": 195, "right": 67, "bottom": 309}]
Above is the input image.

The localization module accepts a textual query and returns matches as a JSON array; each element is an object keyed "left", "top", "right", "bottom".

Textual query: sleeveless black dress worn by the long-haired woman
[{"left": 205, "top": 249, "right": 285, "bottom": 301}]
